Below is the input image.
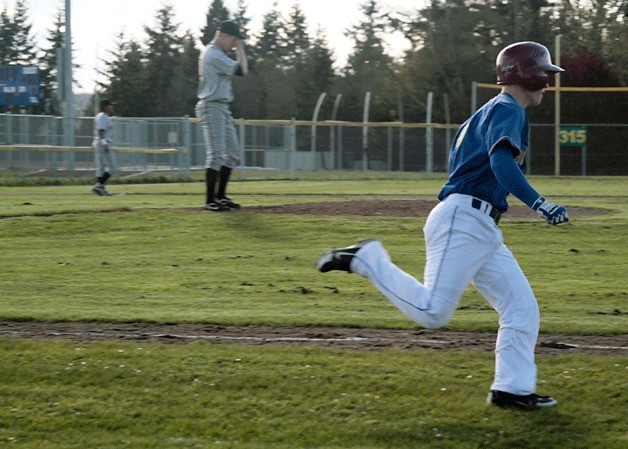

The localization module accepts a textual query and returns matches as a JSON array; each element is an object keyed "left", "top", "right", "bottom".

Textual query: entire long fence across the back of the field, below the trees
[{"left": 0, "top": 114, "right": 628, "bottom": 179}]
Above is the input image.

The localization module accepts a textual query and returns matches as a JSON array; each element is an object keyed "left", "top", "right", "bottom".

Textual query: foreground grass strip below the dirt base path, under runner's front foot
[{"left": 0, "top": 340, "right": 628, "bottom": 449}]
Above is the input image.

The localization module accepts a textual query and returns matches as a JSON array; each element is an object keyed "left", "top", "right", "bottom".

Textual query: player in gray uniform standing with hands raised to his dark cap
[{"left": 195, "top": 21, "right": 249, "bottom": 212}]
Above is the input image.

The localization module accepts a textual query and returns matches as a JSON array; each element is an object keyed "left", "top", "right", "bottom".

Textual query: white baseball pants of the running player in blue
[{"left": 351, "top": 194, "right": 540, "bottom": 395}]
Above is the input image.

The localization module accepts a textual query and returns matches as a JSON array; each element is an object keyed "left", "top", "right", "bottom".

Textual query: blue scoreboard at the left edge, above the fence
[{"left": 0, "top": 65, "right": 40, "bottom": 106}]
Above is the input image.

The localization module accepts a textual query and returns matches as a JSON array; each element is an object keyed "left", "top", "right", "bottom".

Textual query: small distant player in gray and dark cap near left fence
[{"left": 92, "top": 100, "right": 116, "bottom": 196}]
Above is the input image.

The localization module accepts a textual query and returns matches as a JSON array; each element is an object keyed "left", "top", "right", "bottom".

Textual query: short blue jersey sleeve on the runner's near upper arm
[{"left": 485, "top": 104, "right": 528, "bottom": 156}]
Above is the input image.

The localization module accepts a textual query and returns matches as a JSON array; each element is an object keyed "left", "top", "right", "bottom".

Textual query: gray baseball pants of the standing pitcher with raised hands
[{"left": 195, "top": 100, "right": 240, "bottom": 171}]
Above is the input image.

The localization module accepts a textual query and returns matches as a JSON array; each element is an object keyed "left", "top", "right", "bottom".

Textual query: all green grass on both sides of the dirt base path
[{"left": 0, "top": 174, "right": 628, "bottom": 448}]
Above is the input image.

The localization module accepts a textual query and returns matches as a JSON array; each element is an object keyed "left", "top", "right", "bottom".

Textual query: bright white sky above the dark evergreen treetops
[{"left": 9, "top": 0, "right": 424, "bottom": 92}]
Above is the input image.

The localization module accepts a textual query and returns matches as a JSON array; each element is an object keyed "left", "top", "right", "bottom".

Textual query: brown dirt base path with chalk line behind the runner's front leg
[{"left": 0, "top": 320, "right": 628, "bottom": 356}]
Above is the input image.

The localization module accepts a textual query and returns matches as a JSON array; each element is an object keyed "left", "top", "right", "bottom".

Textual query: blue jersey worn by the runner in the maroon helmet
[{"left": 438, "top": 94, "right": 529, "bottom": 212}]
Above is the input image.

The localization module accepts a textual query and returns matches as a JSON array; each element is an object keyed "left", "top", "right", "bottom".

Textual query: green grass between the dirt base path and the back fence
[{"left": 0, "top": 178, "right": 628, "bottom": 333}]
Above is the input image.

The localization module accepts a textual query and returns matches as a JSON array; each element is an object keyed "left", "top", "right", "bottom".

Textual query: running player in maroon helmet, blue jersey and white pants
[{"left": 317, "top": 42, "right": 569, "bottom": 410}]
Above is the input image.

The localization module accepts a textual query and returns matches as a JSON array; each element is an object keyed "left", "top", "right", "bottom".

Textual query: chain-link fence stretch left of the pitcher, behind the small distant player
[{"left": 0, "top": 114, "right": 190, "bottom": 178}]
